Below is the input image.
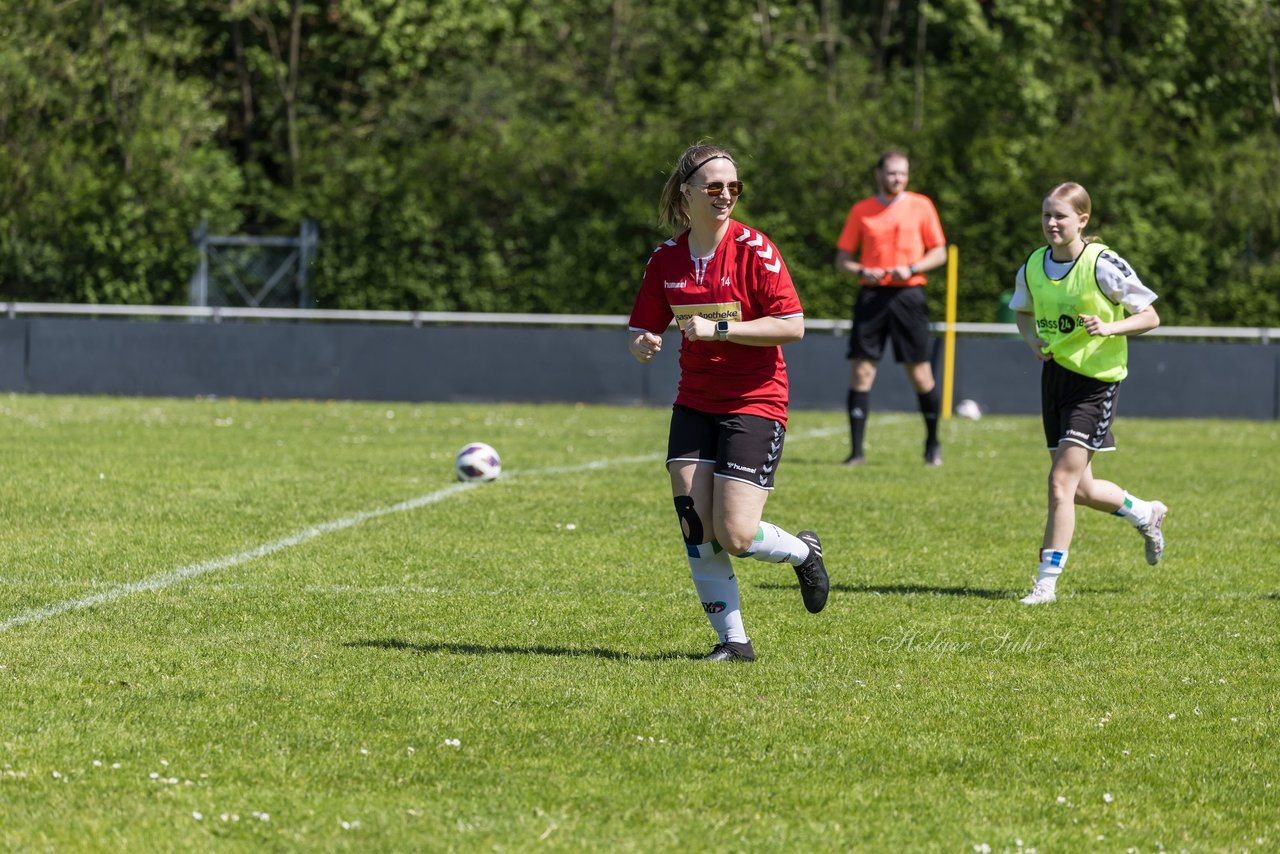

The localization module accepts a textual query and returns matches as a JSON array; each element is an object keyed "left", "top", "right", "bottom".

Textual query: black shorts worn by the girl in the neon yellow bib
[{"left": 1041, "top": 362, "right": 1120, "bottom": 451}]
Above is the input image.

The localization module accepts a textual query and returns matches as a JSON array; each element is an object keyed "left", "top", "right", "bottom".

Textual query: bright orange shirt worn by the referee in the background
[{"left": 836, "top": 191, "right": 947, "bottom": 287}]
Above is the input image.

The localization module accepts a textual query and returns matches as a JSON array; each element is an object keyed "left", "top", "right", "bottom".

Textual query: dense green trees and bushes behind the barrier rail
[{"left": 0, "top": 0, "right": 1280, "bottom": 325}]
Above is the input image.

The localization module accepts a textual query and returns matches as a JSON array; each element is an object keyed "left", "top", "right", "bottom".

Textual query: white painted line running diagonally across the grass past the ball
[{"left": 0, "top": 429, "right": 838, "bottom": 631}]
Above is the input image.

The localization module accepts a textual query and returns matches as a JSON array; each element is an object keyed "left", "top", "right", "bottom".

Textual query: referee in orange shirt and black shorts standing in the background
[{"left": 836, "top": 150, "right": 947, "bottom": 466}]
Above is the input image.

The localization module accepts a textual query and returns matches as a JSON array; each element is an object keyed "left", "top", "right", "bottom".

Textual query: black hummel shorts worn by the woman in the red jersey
[{"left": 667, "top": 403, "right": 786, "bottom": 489}]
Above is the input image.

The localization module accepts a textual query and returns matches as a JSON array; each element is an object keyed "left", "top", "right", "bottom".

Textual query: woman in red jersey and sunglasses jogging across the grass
[{"left": 628, "top": 145, "right": 829, "bottom": 661}]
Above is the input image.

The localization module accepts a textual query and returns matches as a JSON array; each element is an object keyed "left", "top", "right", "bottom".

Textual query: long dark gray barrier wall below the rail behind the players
[{"left": 0, "top": 318, "right": 1280, "bottom": 420}]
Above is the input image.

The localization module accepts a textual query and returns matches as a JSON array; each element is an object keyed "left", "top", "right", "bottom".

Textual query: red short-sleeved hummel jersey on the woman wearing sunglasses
[{"left": 630, "top": 220, "right": 804, "bottom": 426}]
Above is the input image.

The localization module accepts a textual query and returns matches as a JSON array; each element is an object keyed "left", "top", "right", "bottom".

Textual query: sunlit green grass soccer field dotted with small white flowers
[{"left": 0, "top": 396, "right": 1280, "bottom": 851}]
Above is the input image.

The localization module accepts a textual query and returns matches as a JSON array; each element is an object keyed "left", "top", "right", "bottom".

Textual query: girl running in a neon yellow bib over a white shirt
[{"left": 1009, "top": 183, "right": 1169, "bottom": 604}]
